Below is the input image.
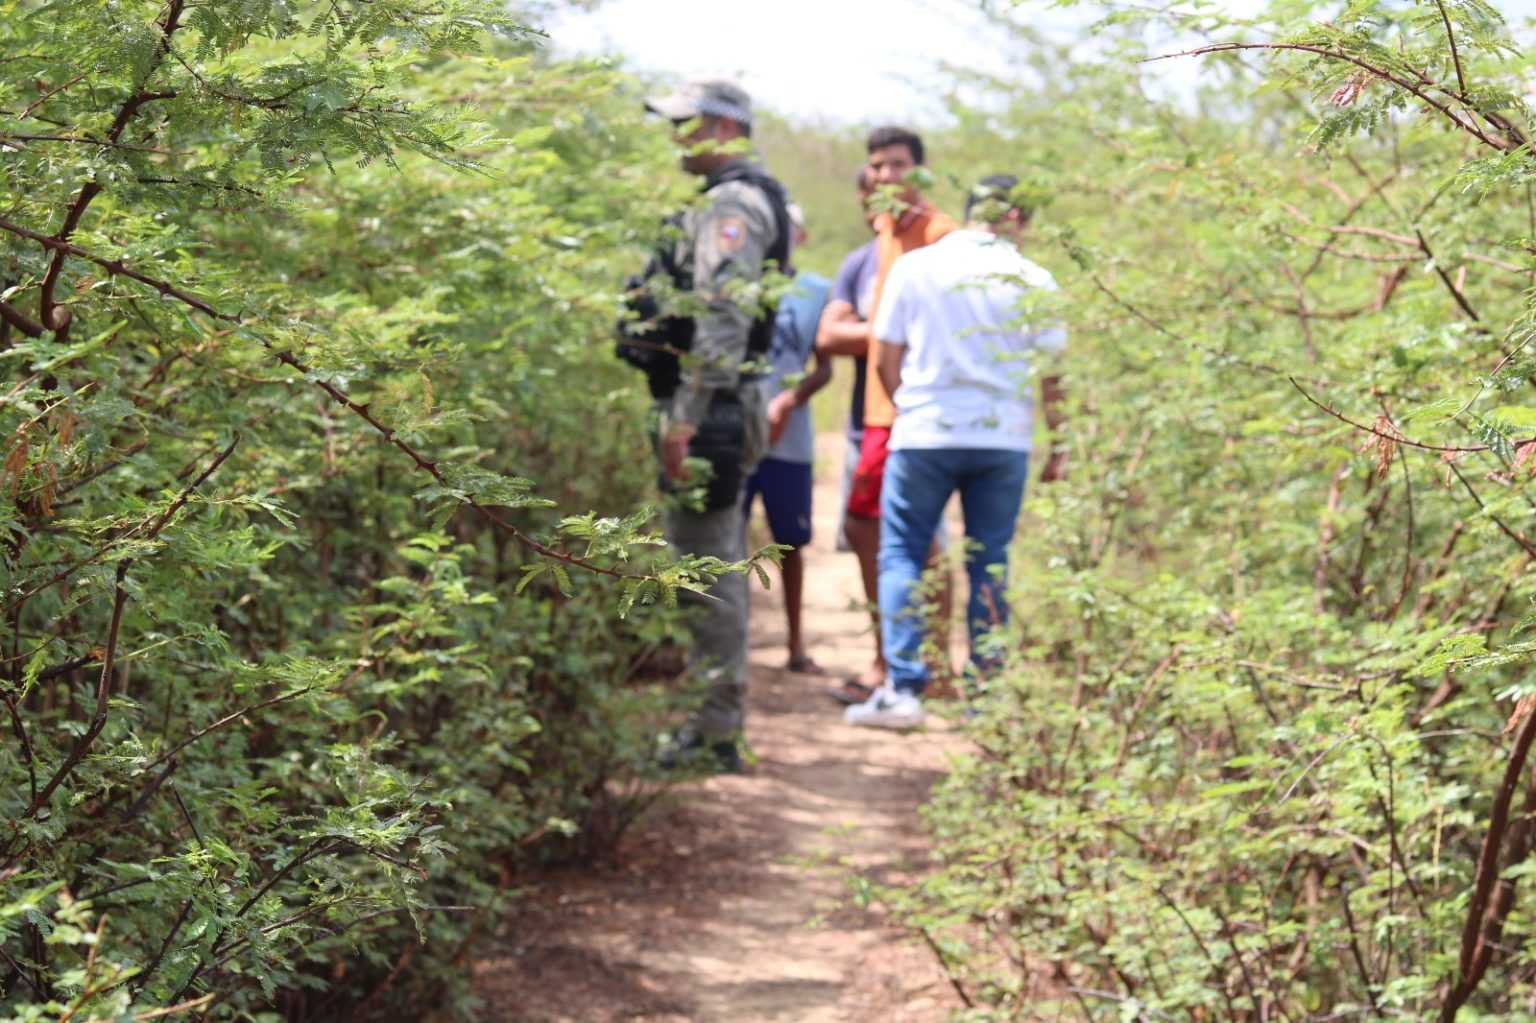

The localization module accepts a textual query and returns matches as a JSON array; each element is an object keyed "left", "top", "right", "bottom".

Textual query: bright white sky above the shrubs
[{"left": 545, "top": 0, "right": 1536, "bottom": 124}]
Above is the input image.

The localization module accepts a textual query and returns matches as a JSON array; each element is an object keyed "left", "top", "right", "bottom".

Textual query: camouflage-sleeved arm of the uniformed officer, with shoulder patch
[{"left": 662, "top": 194, "right": 774, "bottom": 479}]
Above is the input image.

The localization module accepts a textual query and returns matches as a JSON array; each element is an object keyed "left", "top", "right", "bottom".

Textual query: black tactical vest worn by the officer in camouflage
[{"left": 616, "top": 160, "right": 793, "bottom": 399}]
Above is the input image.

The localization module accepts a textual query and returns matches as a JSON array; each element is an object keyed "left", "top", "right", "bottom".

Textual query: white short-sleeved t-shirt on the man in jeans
[{"left": 874, "top": 229, "right": 1066, "bottom": 452}]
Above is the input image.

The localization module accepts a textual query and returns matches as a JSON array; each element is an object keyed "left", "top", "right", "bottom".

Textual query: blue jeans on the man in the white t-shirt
[{"left": 879, "top": 447, "right": 1029, "bottom": 693}]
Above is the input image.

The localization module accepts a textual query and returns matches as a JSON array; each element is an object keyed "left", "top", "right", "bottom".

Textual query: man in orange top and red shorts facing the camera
[{"left": 837, "top": 126, "right": 960, "bottom": 702}]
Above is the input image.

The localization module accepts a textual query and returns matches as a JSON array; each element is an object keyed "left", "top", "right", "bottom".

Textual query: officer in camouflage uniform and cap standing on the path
[{"left": 621, "top": 78, "right": 791, "bottom": 771}]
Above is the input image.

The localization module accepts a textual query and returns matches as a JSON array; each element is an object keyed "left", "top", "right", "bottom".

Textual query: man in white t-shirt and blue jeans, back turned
[{"left": 845, "top": 175, "right": 1066, "bottom": 728}]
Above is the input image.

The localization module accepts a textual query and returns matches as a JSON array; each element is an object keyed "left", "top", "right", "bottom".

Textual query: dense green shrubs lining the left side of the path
[{"left": 0, "top": 0, "right": 743, "bottom": 1020}]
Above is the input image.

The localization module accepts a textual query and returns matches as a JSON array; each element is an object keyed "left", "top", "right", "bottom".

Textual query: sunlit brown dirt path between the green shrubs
[{"left": 476, "top": 436, "right": 958, "bottom": 1023}]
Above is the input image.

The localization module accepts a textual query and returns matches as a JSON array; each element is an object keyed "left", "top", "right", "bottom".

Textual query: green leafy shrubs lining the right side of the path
[{"left": 886, "top": 2, "right": 1536, "bottom": 1020}]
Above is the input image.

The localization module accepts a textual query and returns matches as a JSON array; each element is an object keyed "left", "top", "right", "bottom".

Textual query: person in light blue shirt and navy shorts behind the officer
[{"left": 742, "top": 203, "right": 833, "bottom": 673}]
